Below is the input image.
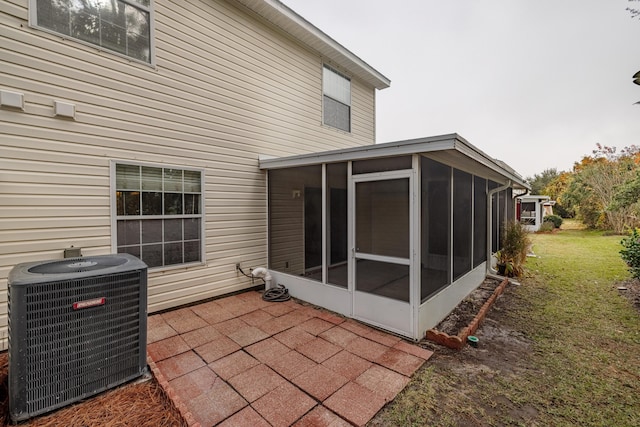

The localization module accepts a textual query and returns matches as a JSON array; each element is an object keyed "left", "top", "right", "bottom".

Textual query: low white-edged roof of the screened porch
[{"left": 260, "top": 133, "right": 531, "bottom": 190}]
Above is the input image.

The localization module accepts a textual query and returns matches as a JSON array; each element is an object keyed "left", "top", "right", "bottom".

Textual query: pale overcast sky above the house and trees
[{"left": 282, "top": 0, "right": 640, "bottom": 177}]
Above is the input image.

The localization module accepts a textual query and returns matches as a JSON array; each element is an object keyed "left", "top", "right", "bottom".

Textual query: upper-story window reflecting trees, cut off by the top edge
[{"left": 31, "top": 0, "right": 151, "bottom": 63}]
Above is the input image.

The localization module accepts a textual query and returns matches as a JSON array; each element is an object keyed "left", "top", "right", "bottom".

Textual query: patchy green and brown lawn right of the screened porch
[{"left": 374, "top": 223, "right": 640, "bottom": 426}]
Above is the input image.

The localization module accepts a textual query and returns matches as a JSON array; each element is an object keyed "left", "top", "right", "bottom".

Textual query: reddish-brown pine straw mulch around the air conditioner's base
[{"left": 0, "top": 352, "right": 187, "bottom": 427}]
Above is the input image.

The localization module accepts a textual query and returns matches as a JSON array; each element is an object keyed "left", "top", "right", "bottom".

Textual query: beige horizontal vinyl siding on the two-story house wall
[{"left": 0, "top": 0, "right": 375, "bottom": 347}]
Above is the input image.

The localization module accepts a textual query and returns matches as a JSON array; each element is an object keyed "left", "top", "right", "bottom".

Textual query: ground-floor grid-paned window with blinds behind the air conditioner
[{"left": 115, "top": 163, "right": 203, "bottom": 267}]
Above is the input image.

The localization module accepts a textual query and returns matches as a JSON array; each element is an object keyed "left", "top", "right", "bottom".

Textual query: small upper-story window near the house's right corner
[{"left": 322, "top": 65, "right": 351, "bottom": 132}]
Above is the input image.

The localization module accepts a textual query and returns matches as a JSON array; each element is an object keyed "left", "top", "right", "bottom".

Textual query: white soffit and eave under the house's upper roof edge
[{"left": 230, "top": 0, "right": 391, "bottom": 89}]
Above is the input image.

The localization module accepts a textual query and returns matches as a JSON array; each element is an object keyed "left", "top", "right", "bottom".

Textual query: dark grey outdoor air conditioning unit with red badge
[{"left": 8, "top": 254, "right": 147, "bottom": 422}]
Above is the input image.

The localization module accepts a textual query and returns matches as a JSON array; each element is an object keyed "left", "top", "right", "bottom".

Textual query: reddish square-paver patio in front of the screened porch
[{"left": 147, "top": 291, "right": 432, "bottom": 427}]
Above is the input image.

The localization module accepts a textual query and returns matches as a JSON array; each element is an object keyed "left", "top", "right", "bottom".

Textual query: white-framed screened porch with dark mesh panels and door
[{"left": 260, "top": 134, "right": 528, "bottom": 339}]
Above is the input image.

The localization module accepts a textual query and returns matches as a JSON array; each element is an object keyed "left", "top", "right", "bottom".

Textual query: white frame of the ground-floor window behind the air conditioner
[{"left": 109, "top": 160, "right": 207, "bottom": 271}]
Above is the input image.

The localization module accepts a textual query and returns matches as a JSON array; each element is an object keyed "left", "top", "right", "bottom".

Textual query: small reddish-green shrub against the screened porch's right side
[{"left": 496, "top": 221, "right": 531, "bottom": 277}]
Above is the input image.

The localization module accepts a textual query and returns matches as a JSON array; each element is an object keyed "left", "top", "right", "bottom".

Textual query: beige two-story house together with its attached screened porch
[{"left": 0, "top": 0, "right": 526, "bottom": 348}]
